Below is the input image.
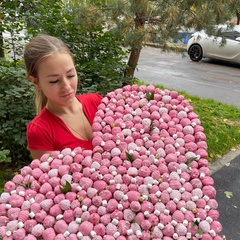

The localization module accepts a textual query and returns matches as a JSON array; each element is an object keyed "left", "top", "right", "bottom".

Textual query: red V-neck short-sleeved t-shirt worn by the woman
[{"left": 27, "top": 93, "right": 102, "bottom": 151}]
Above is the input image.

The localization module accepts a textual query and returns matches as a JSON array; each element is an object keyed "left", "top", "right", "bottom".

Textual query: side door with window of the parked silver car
[{"left": 211, "top": 31, "right": 240, "bottom": 61}]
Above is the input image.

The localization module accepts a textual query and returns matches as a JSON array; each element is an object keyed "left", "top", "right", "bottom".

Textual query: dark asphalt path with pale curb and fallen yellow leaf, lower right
[{"left": 209, "top": 149, "right": 240, "bottom": 240}]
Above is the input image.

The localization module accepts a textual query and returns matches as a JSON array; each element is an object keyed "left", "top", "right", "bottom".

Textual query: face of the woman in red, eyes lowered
[{"left": 31, "top": 52, "right": 78, "bottom": 106}]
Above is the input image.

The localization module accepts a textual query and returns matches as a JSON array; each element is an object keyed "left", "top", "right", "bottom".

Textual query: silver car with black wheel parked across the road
[{"left": 187, "top": 25, "right": 240, "bottom": 63}]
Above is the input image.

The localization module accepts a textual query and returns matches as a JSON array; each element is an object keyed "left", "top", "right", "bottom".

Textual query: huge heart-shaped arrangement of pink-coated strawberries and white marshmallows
[{"left": 0, "top": 85, "right": 222, "bottom": 240}]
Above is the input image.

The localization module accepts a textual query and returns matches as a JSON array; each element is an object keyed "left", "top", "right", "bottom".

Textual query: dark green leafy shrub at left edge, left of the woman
[{"left": 0, "top": 60, "right": 35, "bottom": 161}]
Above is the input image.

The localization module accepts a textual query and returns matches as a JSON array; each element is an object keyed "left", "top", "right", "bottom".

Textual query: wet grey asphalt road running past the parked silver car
[{"left": 134, "top": 47, "right": 240, "bottom": 107}]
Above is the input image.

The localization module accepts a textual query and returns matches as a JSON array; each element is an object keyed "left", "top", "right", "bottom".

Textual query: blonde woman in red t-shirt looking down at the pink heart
[{"left": 24, "top": 35, "right": 102, "bottom": 159}]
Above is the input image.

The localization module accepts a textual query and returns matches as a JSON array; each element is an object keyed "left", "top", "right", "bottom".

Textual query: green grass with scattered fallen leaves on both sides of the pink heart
[{"left": 0, "top": 85, "right": 240, "bottom": 192}]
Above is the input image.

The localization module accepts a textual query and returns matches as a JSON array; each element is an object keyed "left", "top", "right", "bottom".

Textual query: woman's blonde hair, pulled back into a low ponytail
[{"left": 24, "top": 34, "right": 72, "bottom": 114}]
